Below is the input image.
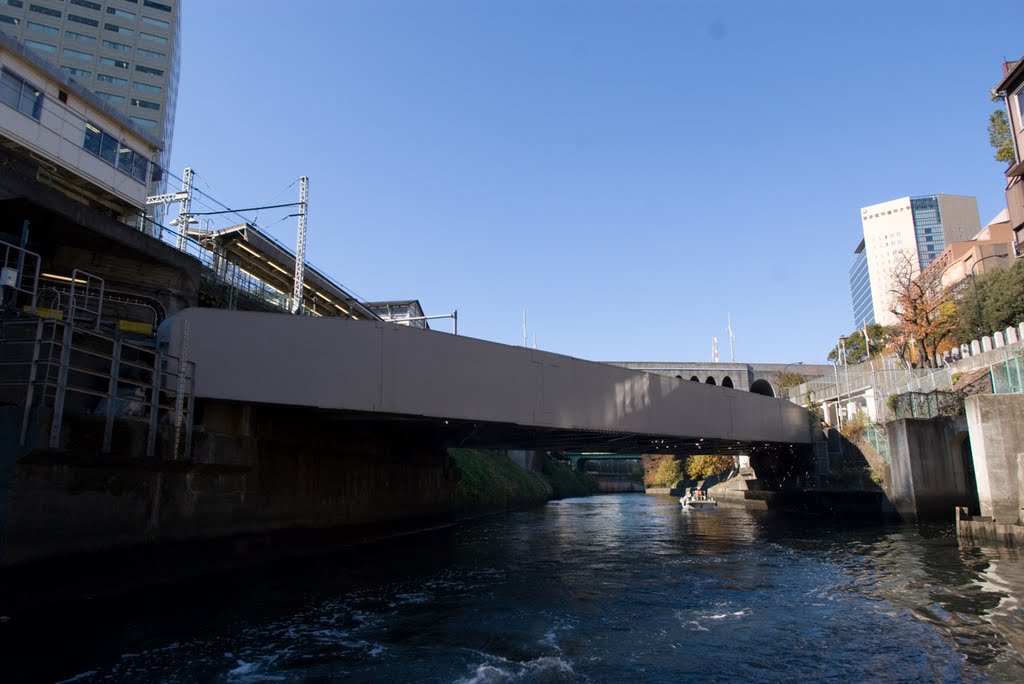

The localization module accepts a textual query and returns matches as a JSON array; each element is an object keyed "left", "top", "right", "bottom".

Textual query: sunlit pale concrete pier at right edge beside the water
[{"left": 965, "top": 394, "right": 1024, "bottom": 524}]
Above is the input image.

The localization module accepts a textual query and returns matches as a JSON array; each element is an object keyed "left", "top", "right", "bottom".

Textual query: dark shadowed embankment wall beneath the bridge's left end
[{"left": 0, "top": 403, "right": 588, "bottom": 566}]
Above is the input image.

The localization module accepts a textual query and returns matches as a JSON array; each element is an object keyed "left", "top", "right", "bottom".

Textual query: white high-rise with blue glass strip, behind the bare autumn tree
[{"left": 851, "top": 195, "right": 981, "bottom": 326}]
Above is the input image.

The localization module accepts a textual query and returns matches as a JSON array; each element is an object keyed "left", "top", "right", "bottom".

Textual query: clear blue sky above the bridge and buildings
[{"left": 171, "top": 0, "right": 1024, "bottom": 362}]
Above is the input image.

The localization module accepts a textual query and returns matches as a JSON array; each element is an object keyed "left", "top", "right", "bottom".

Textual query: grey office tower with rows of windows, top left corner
[{"left": 0, "top": 0, "right": 181, "bottom": 178}]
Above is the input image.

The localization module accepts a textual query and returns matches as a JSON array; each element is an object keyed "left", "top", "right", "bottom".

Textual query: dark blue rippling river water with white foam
[{"left": 6, "top": 495, "right": 1024, "bottom": 683}]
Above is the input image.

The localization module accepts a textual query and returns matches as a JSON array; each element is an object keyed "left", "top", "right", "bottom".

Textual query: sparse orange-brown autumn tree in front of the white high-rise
[{"left": 889, "top": 253, "right": 958, "bottom": 367}]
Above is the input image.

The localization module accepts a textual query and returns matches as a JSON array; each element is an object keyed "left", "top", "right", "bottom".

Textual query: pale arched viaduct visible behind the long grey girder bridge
[{"left": 606, "top": 361, "right": 833, "bottom": 396}]
